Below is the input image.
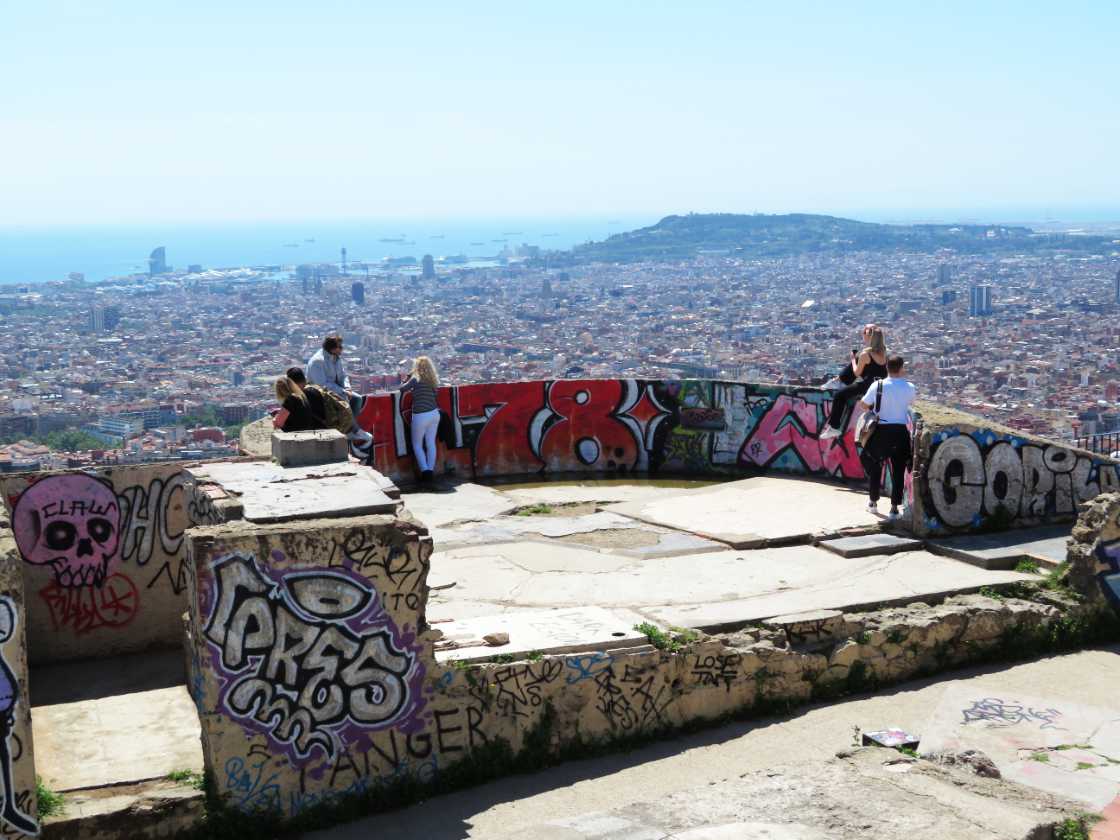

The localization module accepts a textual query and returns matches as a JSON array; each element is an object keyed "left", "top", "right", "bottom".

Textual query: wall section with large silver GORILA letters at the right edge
[{"left": 914, "top": 418, "right": 1120, "bottom": 533}]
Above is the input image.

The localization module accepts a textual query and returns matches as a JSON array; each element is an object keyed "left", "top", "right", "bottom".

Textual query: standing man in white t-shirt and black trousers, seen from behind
[{"left": 859, "top": 356, "right": 916, "bottom": 520}]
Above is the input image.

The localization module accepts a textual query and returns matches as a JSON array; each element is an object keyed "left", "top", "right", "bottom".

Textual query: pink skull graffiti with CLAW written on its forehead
[{"left": 12, "top": 475, "right": 121, "bottom": 587}]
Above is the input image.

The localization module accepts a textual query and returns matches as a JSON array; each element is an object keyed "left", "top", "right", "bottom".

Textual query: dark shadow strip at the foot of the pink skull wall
[{"left": 28, "top": 648, "right": 187, "bottom": 707}]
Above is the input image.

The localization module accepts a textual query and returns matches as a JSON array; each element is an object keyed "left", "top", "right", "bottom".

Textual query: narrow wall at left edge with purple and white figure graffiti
[{"left": 0, "top": 528, "right": 39, "bottom": 838}]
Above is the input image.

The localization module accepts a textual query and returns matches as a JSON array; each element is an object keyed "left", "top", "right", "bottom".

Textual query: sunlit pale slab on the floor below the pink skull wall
[{"left": 31, "top": 685, "right": 203, "bottom": 791}]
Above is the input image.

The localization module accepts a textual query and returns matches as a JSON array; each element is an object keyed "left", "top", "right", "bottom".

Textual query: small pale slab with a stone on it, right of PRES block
[{"left": 436, "top": 607, "right": 647, "bottom": 662}]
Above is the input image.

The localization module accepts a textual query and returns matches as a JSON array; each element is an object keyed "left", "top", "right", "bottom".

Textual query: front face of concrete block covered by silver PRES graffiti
[{"left": 188, "top": 516, "right": 432, "bottom": 810}]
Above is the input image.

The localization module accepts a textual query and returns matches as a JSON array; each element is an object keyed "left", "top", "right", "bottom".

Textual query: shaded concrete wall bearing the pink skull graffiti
[{"left": 2, "top": 464, "right": 204, "bottom": 662}]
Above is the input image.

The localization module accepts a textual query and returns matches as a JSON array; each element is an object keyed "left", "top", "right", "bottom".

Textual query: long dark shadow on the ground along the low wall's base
[{"left": 301, "top": 644, "right": 1120, "bottom": 840}]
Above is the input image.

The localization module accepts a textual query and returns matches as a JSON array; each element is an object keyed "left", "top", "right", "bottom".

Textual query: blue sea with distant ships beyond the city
[{"left": 0, "top": 216, "right": 657, "bottom": 286}]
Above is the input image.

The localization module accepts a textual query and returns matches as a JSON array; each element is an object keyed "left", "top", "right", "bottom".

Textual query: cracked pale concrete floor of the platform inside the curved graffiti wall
[{"left": 416, "top": 477, "right": 1027, "bottom": 629}]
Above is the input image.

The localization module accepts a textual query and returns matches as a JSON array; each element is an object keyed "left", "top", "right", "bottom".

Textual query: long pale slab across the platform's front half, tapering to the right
[{"left": 429, "top": 541, "right": 1030, "bottom": 628}]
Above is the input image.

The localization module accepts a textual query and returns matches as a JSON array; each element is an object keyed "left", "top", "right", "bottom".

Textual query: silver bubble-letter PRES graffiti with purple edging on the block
[{"left": 205, "top": 554, "right": 421, "bottom": 760}]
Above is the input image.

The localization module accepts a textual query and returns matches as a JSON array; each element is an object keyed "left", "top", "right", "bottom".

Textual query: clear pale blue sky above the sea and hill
[{"left": 0, "top": 0, "right": 1120, "bottom": 225}]
